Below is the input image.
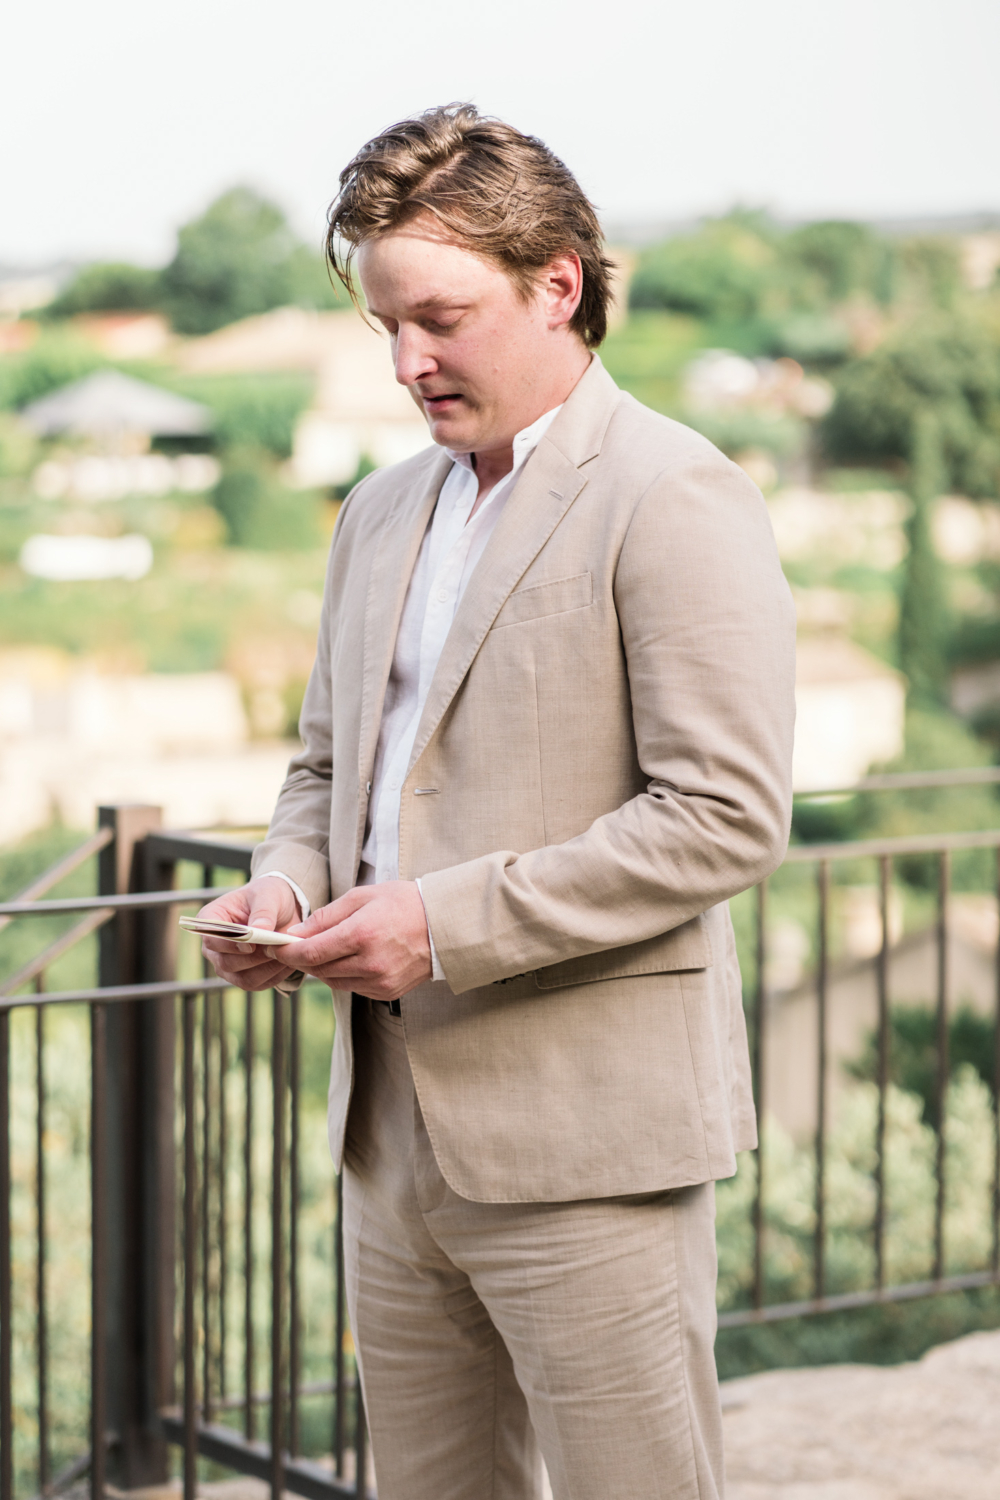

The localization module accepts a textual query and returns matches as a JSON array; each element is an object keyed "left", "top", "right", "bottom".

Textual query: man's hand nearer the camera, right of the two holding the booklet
[{"left": 284, "top": 881, "right": 432, "bottom": 1001}]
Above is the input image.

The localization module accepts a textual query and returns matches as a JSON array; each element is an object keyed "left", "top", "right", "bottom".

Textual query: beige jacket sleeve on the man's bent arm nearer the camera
[{"left": 421, "top": 453, "right": 795, "bottom": 993}]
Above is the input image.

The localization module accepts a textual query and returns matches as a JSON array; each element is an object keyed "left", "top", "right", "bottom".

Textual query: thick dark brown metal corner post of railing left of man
[{"left": 94, "top": 806, "right": 175, "bottom": 1490}]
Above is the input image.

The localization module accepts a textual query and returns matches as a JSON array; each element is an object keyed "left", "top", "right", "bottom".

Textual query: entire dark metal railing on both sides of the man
[{"left": 0, "top": 783, "right": 1000, "bottom": 1500}]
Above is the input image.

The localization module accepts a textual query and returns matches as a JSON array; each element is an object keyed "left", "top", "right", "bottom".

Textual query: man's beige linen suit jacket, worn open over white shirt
[{"left": 253, "top": 359, "right": 795, "bottom": 1202}]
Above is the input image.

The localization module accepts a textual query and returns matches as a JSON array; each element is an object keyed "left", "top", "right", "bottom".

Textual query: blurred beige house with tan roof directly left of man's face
[{"left": 175, "top": 308, "right": 430, "bottom": 486}]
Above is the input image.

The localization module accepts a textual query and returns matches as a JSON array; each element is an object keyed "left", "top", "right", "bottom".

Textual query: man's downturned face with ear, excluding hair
[{"left": 358, "top": 216, "right": 589, "bottom": 453}]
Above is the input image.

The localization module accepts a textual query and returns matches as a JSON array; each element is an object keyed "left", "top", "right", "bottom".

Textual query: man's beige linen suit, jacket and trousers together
[{"left": 253, "top": 359, "right": 795, "bottom": 1500}]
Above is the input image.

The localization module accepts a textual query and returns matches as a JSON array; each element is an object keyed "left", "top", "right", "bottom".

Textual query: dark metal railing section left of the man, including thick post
[{"left": 0, "top": 807, "right": 367, "bottom": 1500}]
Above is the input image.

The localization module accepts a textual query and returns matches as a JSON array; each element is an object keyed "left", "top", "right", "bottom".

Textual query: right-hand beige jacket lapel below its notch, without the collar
[{"left": 409, "top": 437, "right": 586, "bottom": 767}]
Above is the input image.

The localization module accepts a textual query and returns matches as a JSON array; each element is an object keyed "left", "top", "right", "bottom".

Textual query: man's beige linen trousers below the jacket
[{"left": 343, "top": 998, "right": 723, "bottom": 1500}]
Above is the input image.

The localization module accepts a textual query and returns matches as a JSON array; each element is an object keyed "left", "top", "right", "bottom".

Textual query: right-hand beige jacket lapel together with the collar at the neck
[{"left": 409, "top": 356, "right": 621, "bottom": 767}]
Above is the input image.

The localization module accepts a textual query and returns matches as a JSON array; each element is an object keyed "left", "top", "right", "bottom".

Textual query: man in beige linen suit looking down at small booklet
[{"left": 205, "top": 105, "right": 793, "bottom": 1500}]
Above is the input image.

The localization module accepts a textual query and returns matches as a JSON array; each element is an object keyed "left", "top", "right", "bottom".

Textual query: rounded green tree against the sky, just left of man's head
[{"left": 162, "top": 188, "right": 342, "bottom": 333}]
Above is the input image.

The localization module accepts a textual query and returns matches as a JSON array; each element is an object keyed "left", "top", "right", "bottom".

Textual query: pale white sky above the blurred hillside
[{"left": 0, "top": 0, "right": 1000, "bottom": 267}]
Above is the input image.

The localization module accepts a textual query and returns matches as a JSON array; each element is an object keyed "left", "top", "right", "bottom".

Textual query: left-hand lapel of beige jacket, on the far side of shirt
[{"left": 358, "top": 450, "right": 451, "bottom": 783}]
